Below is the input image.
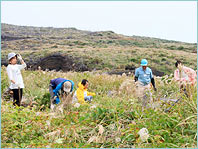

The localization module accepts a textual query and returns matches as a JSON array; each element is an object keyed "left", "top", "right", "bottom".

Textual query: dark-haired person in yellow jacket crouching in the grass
[{"left": 74, "top": 79, "right": 96, "bottom": 104}]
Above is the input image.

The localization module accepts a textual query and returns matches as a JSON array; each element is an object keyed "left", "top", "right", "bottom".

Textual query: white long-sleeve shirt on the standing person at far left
[{"left": 7, "top": 63, "right": 26, "bottom": 89}]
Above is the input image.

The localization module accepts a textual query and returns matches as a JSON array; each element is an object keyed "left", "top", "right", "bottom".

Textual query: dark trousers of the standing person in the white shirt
[{"left": 12, "top": 88, "right": 23, "bottom": 106}]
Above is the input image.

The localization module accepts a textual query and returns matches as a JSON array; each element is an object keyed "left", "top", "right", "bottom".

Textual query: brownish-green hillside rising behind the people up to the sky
[{"left": 1, "top": 23, "right": 197, "bottom": 75}]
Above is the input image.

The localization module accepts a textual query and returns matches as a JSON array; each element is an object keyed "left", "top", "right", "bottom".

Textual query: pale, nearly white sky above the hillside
[{"left": 1, "top": 1, "right": 197, "bottom": 43}]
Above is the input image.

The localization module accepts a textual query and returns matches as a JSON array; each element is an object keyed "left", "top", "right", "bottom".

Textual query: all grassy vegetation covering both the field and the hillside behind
[{"left": 1, "top": 24, "right": 197, "bottom": 148}]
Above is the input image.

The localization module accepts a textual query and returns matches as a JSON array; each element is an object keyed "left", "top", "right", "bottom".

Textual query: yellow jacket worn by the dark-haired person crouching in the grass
[{"left": 76, "top": 82, "right": 96, "bottom": 104}]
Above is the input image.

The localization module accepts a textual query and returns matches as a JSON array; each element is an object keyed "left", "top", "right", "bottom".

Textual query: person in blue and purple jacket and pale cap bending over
[{"left": 49, "top": 78, "right": 74, "bottom": 107}]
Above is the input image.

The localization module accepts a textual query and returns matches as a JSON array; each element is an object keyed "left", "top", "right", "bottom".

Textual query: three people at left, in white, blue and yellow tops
[{"left": 7, "top": 53, "right": 96, "bottom": 106}]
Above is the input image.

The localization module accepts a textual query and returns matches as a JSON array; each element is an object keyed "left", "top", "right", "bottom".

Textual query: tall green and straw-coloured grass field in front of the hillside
[{"left": 1, "top": 67, "right": 197, "bottom": 148}]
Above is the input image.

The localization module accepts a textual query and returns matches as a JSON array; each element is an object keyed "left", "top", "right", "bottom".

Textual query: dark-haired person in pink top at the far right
[{"left": 174, "top": 60, "right": 197, "bottom": 97}]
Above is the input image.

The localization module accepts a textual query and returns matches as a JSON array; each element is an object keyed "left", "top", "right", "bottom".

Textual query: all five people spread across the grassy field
[{"left": 7, "top": 53, "right": 197, "bottom": 106}]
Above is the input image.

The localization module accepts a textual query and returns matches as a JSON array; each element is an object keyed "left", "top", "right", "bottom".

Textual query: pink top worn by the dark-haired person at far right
[{"left": 174, "top": 66, "right": 197, "bottom": 84}]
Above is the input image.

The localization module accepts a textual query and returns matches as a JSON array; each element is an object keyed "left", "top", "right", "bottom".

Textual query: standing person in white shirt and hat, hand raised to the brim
[{"left": 7, "top": 53, "right": 26, "bottom": 106}]
